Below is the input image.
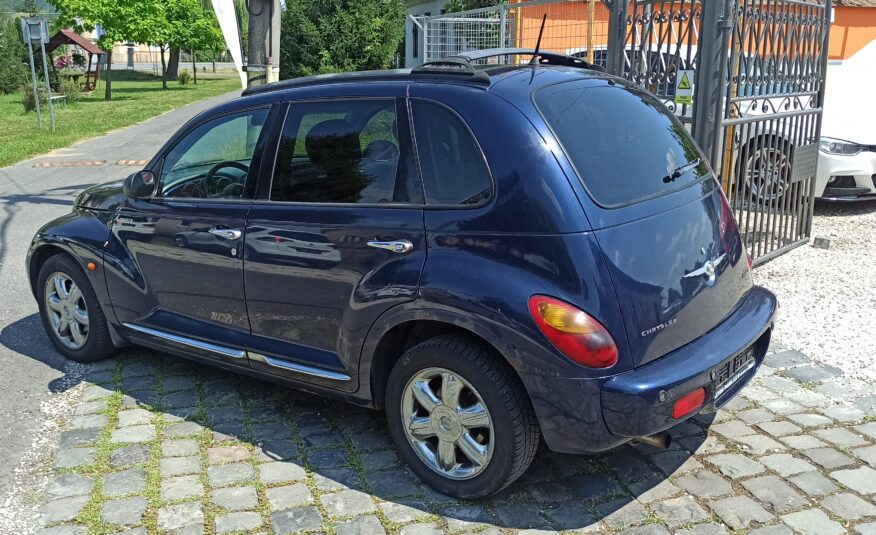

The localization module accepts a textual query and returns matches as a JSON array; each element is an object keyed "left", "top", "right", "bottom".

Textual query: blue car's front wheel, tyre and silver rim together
[{"left": 37, "top": 254, "right": 115, "bottom": 362}]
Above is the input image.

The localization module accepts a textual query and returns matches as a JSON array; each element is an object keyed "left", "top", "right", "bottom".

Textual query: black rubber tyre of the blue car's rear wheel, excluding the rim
[{"left": 386, "top": 335, "right": 541, "bottom": 498}]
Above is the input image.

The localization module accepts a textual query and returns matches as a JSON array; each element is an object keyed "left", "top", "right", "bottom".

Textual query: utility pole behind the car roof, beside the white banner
[{"left": 246, "top": 0, "right": 280, "bottom": 87}]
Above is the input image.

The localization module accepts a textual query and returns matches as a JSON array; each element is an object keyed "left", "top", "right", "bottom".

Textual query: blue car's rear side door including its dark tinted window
[{"left": 244, "top": 93, "right": 426, "bottom": 391}]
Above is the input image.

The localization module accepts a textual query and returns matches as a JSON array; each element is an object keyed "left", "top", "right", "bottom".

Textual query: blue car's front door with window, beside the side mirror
[{"left": 107, "top": 107, "right": 269, "bottom": 364}]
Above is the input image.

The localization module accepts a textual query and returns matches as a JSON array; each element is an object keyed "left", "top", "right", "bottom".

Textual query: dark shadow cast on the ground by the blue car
[{"left": 10, "top": 315, "right": 713, "bottom": 531}]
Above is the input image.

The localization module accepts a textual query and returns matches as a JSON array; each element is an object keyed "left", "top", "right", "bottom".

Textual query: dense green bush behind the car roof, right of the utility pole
[{"left": 280, "top": 0, "right": 405, "bottom": 78}]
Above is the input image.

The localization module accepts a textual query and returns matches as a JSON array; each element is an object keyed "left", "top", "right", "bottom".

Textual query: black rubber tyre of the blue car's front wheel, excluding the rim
[{"left": 36, "top": 254, "right": 116, "bottom": 363}]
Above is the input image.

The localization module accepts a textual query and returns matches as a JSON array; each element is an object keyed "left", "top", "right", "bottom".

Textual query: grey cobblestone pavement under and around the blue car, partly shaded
[{"left": 29, "top": 346, "right": 876, "bottom": 535}]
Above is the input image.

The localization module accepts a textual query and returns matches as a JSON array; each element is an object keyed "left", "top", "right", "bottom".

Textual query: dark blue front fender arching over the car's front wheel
[{"left": 25, "top": 208, "right": 115, "bottom": 323}]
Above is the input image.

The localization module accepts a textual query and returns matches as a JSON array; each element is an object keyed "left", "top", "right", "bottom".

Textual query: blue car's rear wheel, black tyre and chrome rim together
[{"left": 386, "top": 335, "right": 540, "bottom": 498}]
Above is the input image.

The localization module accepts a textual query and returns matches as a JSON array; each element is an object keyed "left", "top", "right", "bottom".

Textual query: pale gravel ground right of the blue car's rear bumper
[{"left": 754, "top": 202, "right": 876, "bottom": 380}]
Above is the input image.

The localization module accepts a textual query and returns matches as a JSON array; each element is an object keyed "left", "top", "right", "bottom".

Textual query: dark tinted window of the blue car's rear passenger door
[{"left": 271, "top": 99, "right": 423, "bottom": 204}]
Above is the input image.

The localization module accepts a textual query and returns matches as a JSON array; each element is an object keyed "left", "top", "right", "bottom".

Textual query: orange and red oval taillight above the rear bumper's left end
[{"left": 529, "top": 295, "right": 617, "bottom": 368}]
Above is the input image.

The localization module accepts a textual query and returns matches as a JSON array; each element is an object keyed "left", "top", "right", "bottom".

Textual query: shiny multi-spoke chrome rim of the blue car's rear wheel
[{"left": 401, "top": 368, "right": 494, "bottom": 479}]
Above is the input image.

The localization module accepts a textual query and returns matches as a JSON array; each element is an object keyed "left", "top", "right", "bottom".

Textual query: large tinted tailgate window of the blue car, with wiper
[{"left": 534, "top": 80, "right": 709, "bottom": 208}]
